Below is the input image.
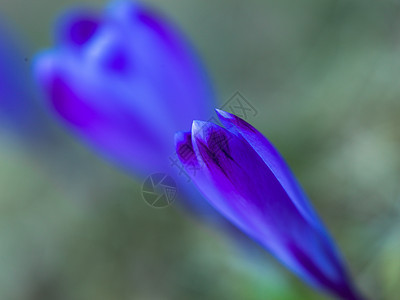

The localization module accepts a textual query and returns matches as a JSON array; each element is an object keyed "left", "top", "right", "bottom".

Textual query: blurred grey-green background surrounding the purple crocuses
[{"left": 0, "top": 0, "right": 400, "bottom": 300}]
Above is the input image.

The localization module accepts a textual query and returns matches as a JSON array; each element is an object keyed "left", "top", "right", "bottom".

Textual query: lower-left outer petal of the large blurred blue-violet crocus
[{"left": 36, "top": 53, "right": 168, "bottom": 175}]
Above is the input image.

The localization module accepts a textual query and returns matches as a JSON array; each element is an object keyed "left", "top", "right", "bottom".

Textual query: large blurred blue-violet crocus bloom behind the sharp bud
[{"left": 35, "top": 1, "right": 214, "bottom": 176}]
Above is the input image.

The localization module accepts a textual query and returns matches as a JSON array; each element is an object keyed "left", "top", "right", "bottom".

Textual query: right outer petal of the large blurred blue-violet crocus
[{"left": 108, "top": 0, "right": 214, "bottom": 131}]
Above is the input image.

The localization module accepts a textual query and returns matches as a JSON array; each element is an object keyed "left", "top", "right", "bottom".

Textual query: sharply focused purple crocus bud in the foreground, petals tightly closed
[{"left": 176, "top": 110, "right": 361, "bottom": 300}]
